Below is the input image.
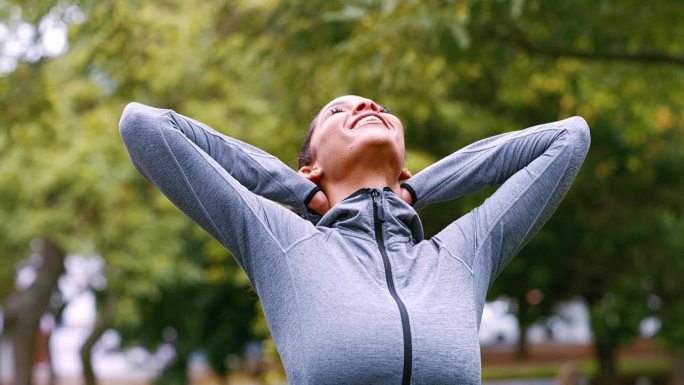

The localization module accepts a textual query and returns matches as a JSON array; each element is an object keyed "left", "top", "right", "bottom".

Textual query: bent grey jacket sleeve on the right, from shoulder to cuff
[{"left": 407, "top": 117, "right": 590, "bottom": 316}]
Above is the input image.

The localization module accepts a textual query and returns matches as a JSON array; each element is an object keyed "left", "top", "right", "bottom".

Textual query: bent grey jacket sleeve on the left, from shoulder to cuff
[{"left": 119, "top": 103, "right": 314, "bottom": 284}]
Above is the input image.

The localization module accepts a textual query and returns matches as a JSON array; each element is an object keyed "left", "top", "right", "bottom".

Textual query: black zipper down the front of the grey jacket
[{"left": 370, "top": 190, "right": 413, "bottom": 385}]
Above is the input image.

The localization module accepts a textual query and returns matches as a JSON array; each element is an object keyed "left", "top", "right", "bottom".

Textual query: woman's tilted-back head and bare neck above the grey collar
[{"left": 299, "top": 95, "right": 411, "bottom": 210}]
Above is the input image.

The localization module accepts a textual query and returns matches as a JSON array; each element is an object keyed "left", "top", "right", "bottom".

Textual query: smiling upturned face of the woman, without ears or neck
[{"left": 304, "top": 95, "right": 406, "bottom": 179}]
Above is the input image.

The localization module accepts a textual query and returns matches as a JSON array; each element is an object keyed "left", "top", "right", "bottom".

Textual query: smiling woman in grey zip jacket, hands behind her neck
[{"left": 120, "top": 95, "right": 589, "bottom": 384}]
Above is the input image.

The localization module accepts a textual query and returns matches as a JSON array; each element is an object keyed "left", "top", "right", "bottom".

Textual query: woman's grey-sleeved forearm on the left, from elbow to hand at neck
[{"left": 122, "top": 103, "right": 324, "bottom": 223}]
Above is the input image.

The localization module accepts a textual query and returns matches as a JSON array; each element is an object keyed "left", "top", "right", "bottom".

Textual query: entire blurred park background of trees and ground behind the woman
[{"left": 0, "top": 0, "right": 684, "bottom": 385}]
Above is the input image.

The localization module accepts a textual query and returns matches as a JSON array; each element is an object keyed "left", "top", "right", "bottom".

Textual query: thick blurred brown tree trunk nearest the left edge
[{"left": 5, "top": 240, "right": 65, "bottom": 385}]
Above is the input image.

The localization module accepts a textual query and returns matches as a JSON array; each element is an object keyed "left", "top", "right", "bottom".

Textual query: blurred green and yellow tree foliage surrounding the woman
[{"left": 0, "top": 0, "right": 684, "bottom": 380}]
